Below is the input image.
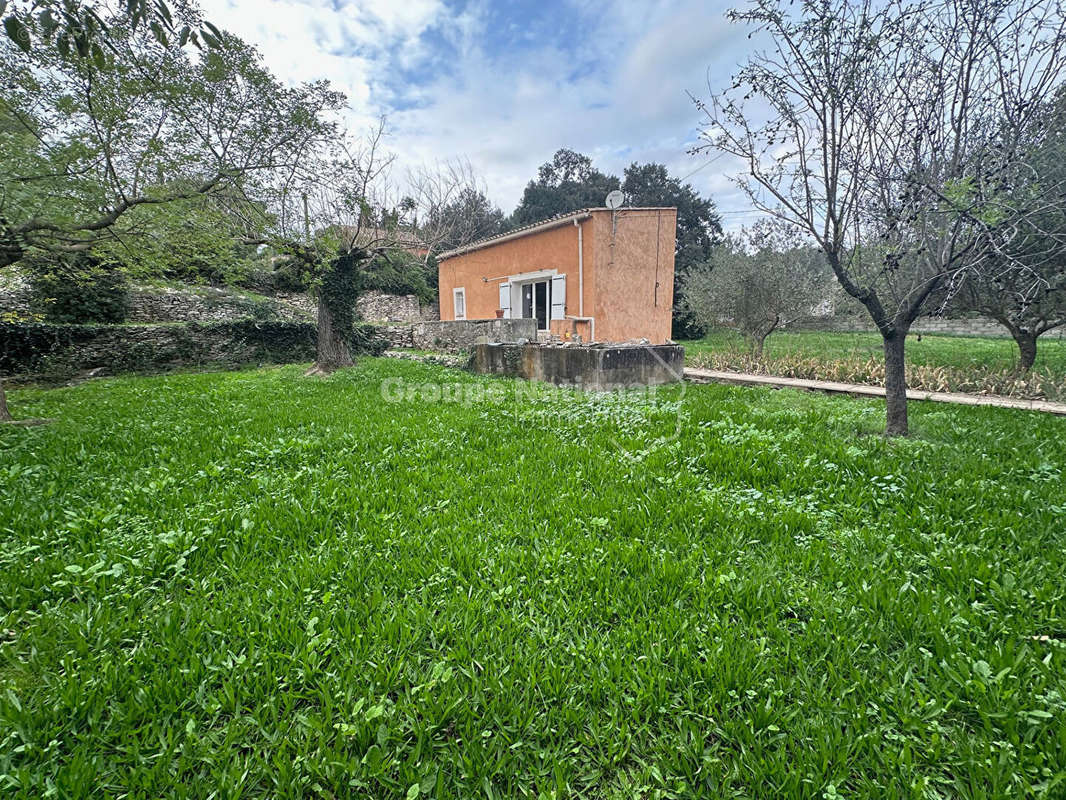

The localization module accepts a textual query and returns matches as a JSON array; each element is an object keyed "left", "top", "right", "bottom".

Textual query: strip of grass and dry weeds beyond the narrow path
[{"left": 682, "top": 331, "right": 1066, "bottom": 400}]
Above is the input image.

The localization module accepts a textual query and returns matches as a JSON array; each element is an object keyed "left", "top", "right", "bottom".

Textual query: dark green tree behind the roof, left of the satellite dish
[{"left": 507, "top": 149, "right": 621, "bottom": 228}]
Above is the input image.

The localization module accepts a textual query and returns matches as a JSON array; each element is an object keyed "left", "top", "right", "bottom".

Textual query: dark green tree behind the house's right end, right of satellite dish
[{"left": 621, "top": 163, "right": 722, "bottom": 338}]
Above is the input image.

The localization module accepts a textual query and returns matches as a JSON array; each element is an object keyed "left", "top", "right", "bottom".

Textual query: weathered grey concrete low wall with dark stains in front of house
[{"left": 471, "top": 343, "right": 684, "bottom": 390}]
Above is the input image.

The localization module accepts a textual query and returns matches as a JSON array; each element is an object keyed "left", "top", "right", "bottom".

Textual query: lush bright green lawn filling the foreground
[{"left": 0, "top": 358, "right": 1066, "bottom": 799}]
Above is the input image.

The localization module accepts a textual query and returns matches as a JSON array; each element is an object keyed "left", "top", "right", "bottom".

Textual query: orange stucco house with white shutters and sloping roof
[{"left": 438, "top": 208, "right": 677, "bottom": 345}]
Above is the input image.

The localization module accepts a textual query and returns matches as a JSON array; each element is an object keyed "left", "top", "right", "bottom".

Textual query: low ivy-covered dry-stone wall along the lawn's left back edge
[{"left": 0, "top": 319, "right": 387, "bottom": 379}]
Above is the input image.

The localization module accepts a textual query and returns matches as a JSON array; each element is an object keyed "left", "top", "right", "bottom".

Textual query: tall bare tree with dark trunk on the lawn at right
[{"left": 697, "top": 0, "right": 1066, "bottom": 435}]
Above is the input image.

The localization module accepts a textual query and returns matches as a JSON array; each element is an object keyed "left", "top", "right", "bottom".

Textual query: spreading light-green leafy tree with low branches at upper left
[{"left": 0, "top": 6, "right": 343, "bottom": 419}]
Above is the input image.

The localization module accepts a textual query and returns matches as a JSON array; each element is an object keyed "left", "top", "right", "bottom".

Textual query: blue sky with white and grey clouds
[{"left": 201, "top": 0, "right": 755, "bottom": 228}]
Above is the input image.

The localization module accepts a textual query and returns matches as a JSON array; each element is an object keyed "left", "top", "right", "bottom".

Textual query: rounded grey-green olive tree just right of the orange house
[{"left": 682, "top": 223, "right": 833, "bottom": 358}]
